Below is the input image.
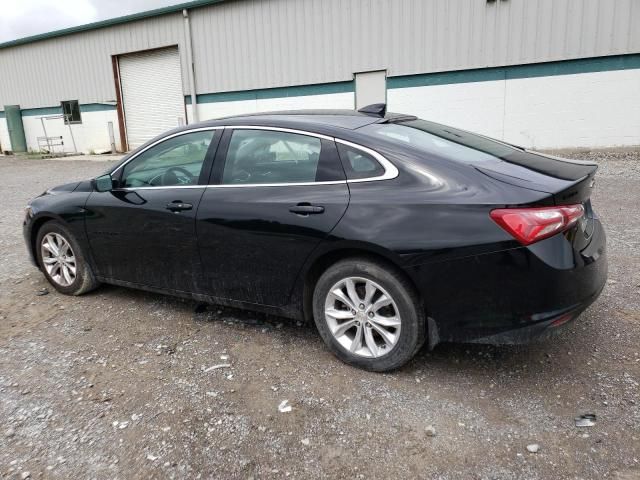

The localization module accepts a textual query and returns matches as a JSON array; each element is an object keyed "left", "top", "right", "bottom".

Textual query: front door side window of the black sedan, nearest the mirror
[{"left": 121, "top": 130, "right": 214, "bottom": 188}]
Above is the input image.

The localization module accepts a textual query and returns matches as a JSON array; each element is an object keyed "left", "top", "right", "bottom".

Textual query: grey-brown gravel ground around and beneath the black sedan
[{"left": 0, "top": 152, "right": 640, "bottom": 479}]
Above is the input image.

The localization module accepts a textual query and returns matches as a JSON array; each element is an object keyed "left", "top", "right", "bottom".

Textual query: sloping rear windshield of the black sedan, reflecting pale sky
[{"left": 360, "top": 120, "right": 518, "bottom": 163}]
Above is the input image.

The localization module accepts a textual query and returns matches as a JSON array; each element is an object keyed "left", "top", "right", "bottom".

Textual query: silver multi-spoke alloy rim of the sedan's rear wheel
[{"left": 324, "top": 277, "right": 402, "bottom": 358}]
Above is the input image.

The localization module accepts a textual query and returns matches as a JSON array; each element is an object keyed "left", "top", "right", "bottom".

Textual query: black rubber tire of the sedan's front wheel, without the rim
[{"left": 35, "top": 220, "right": 100, "bottom": 295}]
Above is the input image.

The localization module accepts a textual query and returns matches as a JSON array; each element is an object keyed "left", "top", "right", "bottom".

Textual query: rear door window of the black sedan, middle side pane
[{"left": 222, "top": 129, "right": 323, "bottom": 185}]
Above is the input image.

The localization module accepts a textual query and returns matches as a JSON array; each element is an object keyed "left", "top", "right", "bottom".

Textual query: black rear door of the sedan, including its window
[{"left": 196, "top": 127, "right": 349, "bottom": 306}]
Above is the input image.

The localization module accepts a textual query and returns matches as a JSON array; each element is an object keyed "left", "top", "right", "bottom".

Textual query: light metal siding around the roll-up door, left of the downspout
[{"left": 0, "top": 13, "right": 187, "bottom": 109}]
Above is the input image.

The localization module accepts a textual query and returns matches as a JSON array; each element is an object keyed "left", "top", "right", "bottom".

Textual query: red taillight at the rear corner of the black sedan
[{"left": 491, "top": 204, "right": 584, "bottom": 245}]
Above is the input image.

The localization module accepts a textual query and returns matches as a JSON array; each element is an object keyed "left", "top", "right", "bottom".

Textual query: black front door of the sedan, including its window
[{"left": 86, "top": 129, "right": 221, "bottom": 292}]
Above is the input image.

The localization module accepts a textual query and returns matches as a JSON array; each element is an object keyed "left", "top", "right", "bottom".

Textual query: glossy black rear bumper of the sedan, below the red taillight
[{"left": 410, "top": 219, "right": 607, "bottom": 344}]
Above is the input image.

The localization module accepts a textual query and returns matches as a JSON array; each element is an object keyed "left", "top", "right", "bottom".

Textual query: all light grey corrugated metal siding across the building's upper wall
[{"left": 0, "top": 0, "right": 640, "bottom": 108}]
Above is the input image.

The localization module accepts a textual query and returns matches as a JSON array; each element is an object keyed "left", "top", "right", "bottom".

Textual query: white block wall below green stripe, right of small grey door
[{"left": 387, "top": 69, "right": 640, "bottom": 148}]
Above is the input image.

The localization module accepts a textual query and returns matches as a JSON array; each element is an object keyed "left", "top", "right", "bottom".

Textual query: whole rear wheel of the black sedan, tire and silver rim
[{"left": 313, "top": 258, "right": 426, "bottom": 372}]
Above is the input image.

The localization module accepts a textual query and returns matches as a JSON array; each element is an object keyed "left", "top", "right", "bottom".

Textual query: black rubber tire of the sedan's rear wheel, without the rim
[{"left": 313, "top": 258, "right": 426, "bottom": 372}]
